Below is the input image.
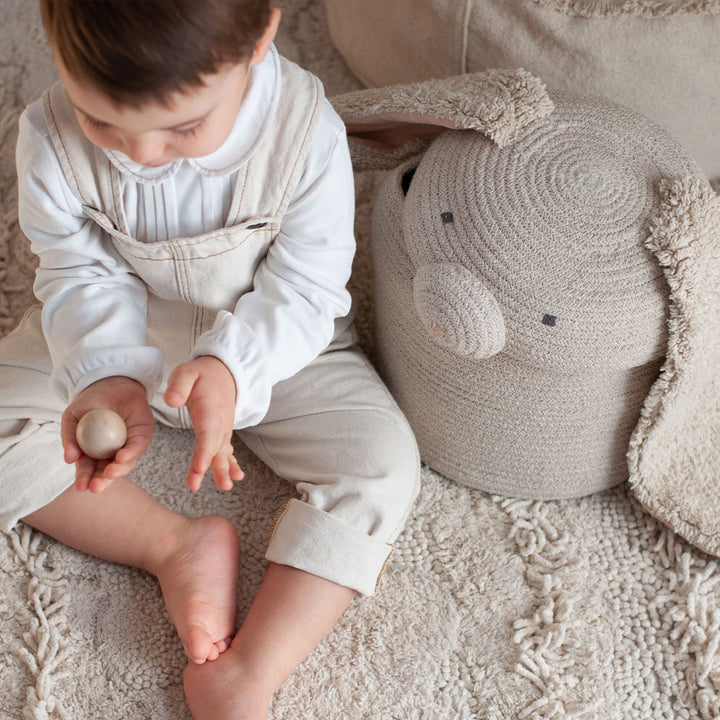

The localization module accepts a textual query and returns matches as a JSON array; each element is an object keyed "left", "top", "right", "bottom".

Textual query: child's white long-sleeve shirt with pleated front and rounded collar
[{"left": 17, "top": 48, "right": 355, "bottom": 427}]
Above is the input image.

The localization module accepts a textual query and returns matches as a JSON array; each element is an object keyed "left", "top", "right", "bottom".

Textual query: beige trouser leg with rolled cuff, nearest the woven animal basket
[{"left": 238, "top": 331, "right": 420, "bottom": 595}]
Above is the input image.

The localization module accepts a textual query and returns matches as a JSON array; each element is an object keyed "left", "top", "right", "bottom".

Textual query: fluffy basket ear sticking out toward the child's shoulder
[{"left": 332, "top": 69, "right": 553, "bottom": 170}]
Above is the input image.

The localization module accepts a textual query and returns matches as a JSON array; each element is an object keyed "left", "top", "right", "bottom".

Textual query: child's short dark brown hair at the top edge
[{"left": 40, "top": 0, "right": 270, "bottom": 107}]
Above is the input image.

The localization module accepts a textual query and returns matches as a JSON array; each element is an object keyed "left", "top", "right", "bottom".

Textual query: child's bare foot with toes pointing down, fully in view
[{"left": 152, "top": 516, "right": 240, "bottom": 663}]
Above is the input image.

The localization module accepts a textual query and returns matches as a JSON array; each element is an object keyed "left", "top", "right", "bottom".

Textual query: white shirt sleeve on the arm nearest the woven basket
[{"left": 193, "top": 102, "right": 355, "bottom": 428}]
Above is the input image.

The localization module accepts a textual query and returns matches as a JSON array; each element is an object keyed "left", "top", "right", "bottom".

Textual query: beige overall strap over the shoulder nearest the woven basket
[{"left": 227, "top": 56, "right": 325, "bottom": 226}]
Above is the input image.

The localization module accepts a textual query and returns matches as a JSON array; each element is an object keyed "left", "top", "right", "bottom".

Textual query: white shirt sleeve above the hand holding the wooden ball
[{"left": 16, "top": 104, "right": 162, "bottom": 402}]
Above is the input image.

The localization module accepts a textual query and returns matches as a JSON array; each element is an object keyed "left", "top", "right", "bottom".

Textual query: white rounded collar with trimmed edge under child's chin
[{"left": 103, "top": 46, "right": 280, "bottom": 184}]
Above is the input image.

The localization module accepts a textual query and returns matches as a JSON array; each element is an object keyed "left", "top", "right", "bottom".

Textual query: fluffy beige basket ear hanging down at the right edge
[{"left": 628, "top": 177, "right": 720, "bottom": 556}]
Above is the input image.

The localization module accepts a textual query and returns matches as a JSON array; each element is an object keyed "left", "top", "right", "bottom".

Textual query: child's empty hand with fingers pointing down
[{"left": 165, "top": 355, "right": 245, "bottom": 490}]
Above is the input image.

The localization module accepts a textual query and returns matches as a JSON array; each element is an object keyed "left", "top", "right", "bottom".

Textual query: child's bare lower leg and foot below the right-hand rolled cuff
[{"left": 185, "top": 563, "right": 355, "bottom": 720}]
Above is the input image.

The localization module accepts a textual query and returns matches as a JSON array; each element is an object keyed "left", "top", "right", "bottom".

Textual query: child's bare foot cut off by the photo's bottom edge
[{"left": 184, "top": 647, "right": 274, "bottom": 720}]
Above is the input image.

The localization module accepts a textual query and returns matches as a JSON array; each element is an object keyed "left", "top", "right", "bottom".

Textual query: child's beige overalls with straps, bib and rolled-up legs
[{"left": 0, "top": 60, "right": 419, "bottom": 594}]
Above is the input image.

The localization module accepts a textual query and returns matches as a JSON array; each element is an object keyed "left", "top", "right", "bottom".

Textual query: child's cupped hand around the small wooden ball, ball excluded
[{"left": 61, "top": 377, "right": 153, "bottom": 493}]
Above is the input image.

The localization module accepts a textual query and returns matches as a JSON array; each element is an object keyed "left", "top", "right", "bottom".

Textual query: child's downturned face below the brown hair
[{"left": 56, "top": 58, "right": 254, "bottom": 166}]
